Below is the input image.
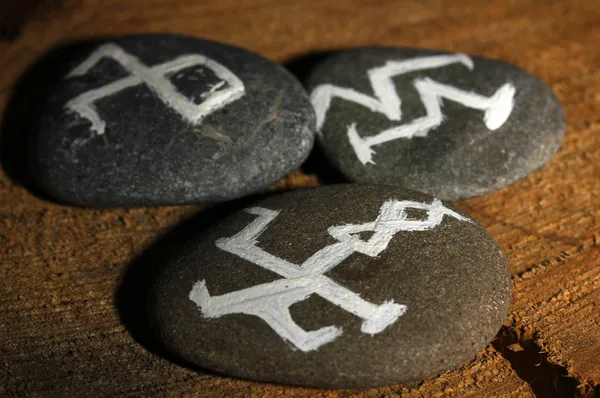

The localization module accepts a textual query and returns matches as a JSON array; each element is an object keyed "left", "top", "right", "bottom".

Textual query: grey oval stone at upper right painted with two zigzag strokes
[{"left": 306, "top": 48, "right": 565, "bottom": 200}]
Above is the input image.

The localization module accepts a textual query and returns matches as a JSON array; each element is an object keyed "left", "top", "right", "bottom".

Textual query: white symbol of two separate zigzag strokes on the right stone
[{"left": 311, "top": 54, "right": 516, "bottom": 165}]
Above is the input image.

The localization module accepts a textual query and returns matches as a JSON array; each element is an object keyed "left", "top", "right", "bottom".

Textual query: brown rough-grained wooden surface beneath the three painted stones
[{"left": 0, "top": 0, "right": 600, "bottom": 397}]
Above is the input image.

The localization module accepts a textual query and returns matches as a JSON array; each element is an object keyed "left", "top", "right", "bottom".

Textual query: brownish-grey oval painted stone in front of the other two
[{"left": 149, "top": 184, "right": 511, "bottom": 388}]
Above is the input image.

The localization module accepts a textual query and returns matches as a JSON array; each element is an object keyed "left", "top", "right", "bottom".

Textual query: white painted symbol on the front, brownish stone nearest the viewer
[{"left": 189, "top": 199, "right": 470, "bottom": 351}]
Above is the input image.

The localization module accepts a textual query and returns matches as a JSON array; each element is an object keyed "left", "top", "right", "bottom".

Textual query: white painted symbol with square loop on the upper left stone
[{"left": 65, "top": 44, "right": 245, "bottom": 134}]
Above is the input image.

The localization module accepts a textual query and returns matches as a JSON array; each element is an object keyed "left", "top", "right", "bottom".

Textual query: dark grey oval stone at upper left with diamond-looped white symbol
[{"left": 33, "top": 35, "right": 315, "bottom": 206}]
